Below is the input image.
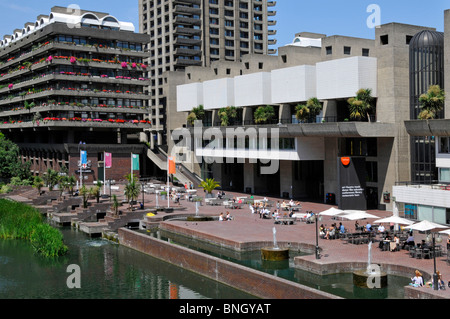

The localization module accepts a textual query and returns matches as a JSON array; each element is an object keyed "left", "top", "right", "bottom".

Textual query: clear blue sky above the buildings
[{"left": 0, "top": 0, "right": 450, "bottom": 48}]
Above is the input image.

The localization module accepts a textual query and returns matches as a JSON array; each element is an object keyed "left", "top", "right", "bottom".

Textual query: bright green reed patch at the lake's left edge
[{"left": 0, "top": 199, "right": 68, "bottom": 258}]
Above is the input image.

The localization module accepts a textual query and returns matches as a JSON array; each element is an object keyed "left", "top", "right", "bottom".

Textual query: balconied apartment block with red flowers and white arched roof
[{"left": 0, "top": 7, "right": 152, "bottom": 182}]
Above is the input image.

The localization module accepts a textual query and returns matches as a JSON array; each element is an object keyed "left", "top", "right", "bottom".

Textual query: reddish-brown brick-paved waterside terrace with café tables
[{"left": 4, "top": 186, "right": 450, "bottom": 298}]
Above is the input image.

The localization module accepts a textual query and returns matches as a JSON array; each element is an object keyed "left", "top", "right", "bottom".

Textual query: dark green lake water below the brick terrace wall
[{"left": 0, "top": 228, "right": 252, "bottom": 299}]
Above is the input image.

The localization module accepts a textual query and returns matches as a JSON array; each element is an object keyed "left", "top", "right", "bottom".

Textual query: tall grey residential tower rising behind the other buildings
[{"left": 139, "top": 0, "right": 276, "bottom": 145}]
